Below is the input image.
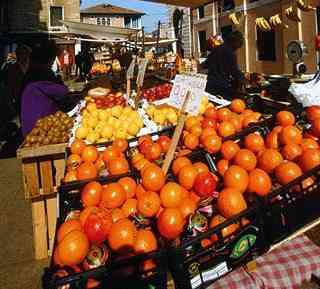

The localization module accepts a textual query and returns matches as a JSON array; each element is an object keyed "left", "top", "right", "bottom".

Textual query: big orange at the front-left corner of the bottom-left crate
[{"left": 56, "top": 230, "right": 90, "bottom": 266}]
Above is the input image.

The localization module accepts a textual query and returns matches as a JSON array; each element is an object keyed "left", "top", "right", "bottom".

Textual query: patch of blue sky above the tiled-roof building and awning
[{"left": 81, "top": 0, "right": 167, "bottom": 32}]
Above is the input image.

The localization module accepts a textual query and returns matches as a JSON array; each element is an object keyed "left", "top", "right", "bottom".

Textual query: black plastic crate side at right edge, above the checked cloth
[{"left": 264, "top": 166, "right": 320, "bottom": 244}]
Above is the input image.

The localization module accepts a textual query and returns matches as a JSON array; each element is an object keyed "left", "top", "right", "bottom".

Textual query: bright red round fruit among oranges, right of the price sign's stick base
[{"left": 194, "top": 172, "right": 217, "bottom": 198}]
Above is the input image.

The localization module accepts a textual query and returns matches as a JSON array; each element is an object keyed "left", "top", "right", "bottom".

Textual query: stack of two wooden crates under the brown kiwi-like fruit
[{"left": 17, "top": 144, "right": 67, "bottom": 260}]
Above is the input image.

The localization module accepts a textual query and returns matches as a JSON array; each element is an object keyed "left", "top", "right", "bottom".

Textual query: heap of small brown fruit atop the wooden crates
[{"left": 23, "top": 111, "right": 73, "bottom": 147}]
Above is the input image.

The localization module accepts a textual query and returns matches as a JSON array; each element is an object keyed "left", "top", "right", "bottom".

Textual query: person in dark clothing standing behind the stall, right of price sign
[{"left": 204, "top": 31, "right": 245, "bottom": 99}]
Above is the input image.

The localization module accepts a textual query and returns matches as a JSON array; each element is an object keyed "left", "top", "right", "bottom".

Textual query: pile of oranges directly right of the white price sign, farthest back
[{"left": 182, "top": 99, "right": 261, "bottom": 153}]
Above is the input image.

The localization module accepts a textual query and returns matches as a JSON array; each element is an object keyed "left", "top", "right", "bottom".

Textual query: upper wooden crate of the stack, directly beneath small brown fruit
[{"left": 17, "top": 144, "right": 67, "bottom": 199}]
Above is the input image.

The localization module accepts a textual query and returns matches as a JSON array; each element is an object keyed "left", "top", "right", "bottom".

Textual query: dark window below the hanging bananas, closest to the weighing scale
[{"left": 257, "top": 28, "right": 276, "bottom": 61}]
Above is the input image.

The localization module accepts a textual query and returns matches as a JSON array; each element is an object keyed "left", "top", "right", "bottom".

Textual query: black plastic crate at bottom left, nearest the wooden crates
[{"left": 42, "top": 174, "right": 168, "bottom": 289}]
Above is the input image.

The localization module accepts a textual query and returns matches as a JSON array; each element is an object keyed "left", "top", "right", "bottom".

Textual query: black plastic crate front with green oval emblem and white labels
[{"left": 169, "top": 204, "right": 269, "bottom": 289}]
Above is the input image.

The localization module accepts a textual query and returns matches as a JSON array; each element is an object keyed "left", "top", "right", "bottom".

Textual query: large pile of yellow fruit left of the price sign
[{"left": 75, "top": 102, "right": 144, "bottom": 144}]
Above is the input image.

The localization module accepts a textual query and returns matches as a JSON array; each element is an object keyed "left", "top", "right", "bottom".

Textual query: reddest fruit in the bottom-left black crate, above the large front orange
[{"left": 84, "top": 214, "right": 107, "bottom": 244}]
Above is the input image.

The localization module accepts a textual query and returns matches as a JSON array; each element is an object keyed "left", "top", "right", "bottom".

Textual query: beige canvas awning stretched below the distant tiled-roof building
[{"left": 61, "top": 21, "right": 139, "bottom": 41}]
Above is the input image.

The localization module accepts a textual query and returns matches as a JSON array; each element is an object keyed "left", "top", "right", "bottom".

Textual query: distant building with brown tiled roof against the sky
[{"left": 81, "top": 4, "right": 144, "bottom": 29}]
